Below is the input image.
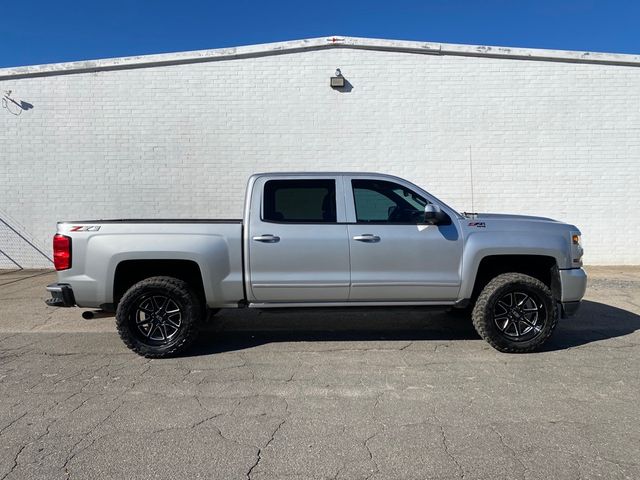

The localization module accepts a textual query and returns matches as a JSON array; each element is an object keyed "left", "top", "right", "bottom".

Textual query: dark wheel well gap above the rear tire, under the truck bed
[{"left": 113, "top": 260, "right": 206, "bottom": 306}]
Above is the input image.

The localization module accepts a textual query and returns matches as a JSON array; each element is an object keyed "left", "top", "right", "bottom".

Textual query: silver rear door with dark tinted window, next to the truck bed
[{"left": 248, "top": 175, "right": 350, "bottom": 302}]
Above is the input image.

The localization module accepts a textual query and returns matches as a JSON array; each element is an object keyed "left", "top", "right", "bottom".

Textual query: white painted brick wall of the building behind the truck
[{"left": 0, "top": 39, "right": 640, "bottom": 267}]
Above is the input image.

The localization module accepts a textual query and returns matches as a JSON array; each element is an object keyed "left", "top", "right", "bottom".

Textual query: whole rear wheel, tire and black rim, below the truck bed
[{"left": 116, "top": 277, "right": 204, "bottom": 358}]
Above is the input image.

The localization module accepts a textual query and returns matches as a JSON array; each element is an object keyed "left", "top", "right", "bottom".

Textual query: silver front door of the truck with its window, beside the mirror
[{"left": 344, "top": 177, "right": 462, "bottom": 301}]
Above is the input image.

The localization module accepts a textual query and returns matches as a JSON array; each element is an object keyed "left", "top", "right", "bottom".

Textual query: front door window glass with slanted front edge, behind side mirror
[{"left": 351, "top": 180, "right": 428, "bottom": 224}]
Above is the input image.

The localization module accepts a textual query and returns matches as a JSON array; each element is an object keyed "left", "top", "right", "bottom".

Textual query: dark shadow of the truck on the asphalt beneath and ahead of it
[{"left": 186, "top": 301, "right": 640, "bottom": 356}]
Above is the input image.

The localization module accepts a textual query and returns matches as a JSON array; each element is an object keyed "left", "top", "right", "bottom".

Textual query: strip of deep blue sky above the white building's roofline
[{"left": 0, "top": 0, "right": 640, "bottom": 67}]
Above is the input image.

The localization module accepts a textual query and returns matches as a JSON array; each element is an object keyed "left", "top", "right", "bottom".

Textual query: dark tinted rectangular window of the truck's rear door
[{"left": 263, "top": 180, "right": 336, "bottom": 223}]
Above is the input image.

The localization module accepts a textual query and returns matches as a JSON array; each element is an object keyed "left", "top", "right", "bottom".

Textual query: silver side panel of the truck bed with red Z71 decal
[{"left": 57, "top": 218, "right": 244, "bottom": 308}]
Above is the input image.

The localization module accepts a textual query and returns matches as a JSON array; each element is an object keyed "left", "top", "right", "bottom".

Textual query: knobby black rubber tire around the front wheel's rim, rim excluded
[{"left": 471, "top": 273, "right": 558, "bottom": 353}]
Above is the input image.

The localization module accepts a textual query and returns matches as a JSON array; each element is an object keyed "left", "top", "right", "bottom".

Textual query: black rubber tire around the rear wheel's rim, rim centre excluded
[{"left": 116, "top": 277, "right": 205, "bottom": 358}]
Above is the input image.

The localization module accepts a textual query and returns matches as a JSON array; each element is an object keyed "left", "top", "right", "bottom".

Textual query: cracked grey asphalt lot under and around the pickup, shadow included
[{"left": 0, "top": 267, "right": 640, "bottom": 480}]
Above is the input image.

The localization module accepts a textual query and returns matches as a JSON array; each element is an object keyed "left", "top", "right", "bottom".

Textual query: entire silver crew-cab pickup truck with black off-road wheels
[{"left": 47, "top": 173, "right": 587, "bottom": 358}]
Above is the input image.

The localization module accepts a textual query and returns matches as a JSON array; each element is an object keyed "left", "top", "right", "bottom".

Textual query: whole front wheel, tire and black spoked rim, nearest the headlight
[{"left": 472, "top": 273, "right": 558, "bottom": 353}]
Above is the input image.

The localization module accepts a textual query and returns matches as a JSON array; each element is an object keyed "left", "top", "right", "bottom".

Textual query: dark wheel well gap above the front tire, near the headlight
[{"left": 472, "top": 255, "right": 559, "bottom": 300}]
